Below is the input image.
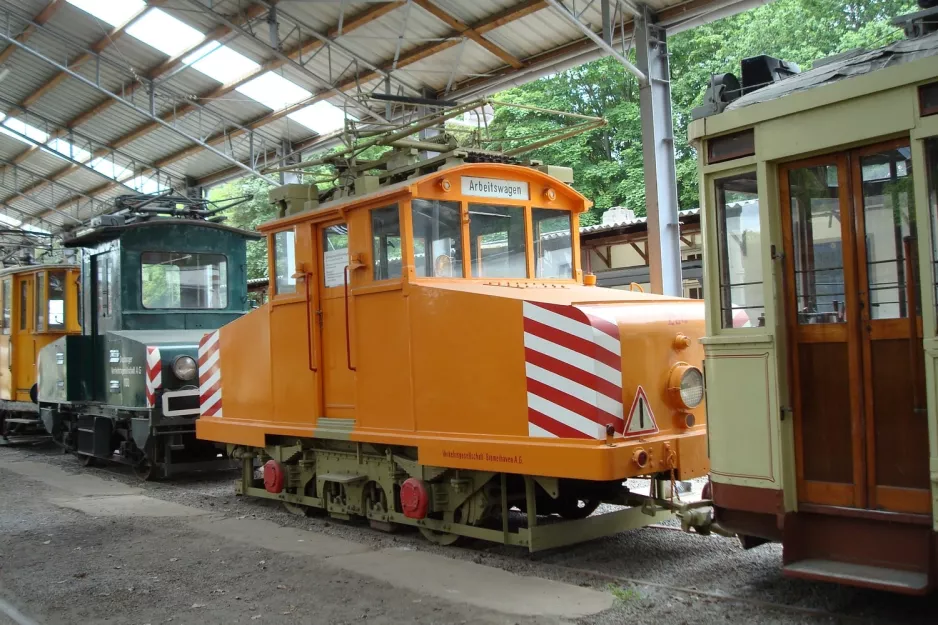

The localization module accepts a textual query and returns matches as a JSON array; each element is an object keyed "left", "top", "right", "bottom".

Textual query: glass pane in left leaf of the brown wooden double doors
[{"left": 788, "top": 164, "right": 847, "bottom": 324}]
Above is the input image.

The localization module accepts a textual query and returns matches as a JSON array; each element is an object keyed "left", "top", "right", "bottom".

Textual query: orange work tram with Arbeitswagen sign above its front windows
[{"left": 197, "top": 162, "right": 711, "bottom": 551}]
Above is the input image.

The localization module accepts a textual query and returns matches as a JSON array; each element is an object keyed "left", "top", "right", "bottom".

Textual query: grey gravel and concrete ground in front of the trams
[{"left": 0, "top": 448, "right": 938, "bottom": 625}]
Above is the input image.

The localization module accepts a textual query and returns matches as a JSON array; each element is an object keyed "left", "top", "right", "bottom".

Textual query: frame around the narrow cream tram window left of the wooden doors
[{"left": 702, "top": 165, "right": 771, "bottom": 335}]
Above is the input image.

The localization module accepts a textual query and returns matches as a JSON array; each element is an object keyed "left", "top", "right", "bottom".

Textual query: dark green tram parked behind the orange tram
[{"left": 38, "top": 194, "right": 259, "bottom": 479}]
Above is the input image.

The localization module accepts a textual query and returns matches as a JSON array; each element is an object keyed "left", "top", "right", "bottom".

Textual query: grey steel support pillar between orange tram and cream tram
[{"left": 635, "top": 6, "right": 684, "bottom": 296}]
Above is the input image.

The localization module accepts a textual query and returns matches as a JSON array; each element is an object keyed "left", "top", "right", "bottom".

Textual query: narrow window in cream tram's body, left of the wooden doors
[{"left": 715, "top": 171, "right": 765, "bottom": 328}]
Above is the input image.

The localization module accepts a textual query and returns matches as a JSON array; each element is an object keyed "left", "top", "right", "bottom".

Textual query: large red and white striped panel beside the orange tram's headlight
[{"left": 523, "top": 302, "right": 625, "bottom": 439}]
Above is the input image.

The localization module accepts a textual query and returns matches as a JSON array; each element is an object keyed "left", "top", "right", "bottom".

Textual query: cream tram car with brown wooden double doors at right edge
[{"left": 689, "top": 26, "right": 938, "bottom": 594}]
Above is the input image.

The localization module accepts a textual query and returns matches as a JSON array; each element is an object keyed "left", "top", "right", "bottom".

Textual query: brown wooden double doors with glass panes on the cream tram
[{"left": 779, "top": 142, "right": 931, "bottom": 514}]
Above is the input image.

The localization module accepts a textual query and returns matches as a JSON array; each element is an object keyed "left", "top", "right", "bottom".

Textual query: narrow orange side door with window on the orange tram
[{"left": 312, "top": 223, "right": 355, "bottom": 419}]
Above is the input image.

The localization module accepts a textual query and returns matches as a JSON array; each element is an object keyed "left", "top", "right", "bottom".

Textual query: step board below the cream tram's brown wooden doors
[{"left": 782, "top": 559, "right": 928, "bottom": 595}]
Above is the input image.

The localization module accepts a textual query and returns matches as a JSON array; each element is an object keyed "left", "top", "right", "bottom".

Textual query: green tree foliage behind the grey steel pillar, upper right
[{"left": 492, "top": 0, "right": 915, "bottom": 224}]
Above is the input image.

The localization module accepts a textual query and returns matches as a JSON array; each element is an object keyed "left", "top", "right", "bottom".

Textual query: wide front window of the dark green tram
[{"left": 140, "top": 252, "right": 228, "bottom": 309}]
